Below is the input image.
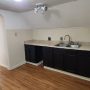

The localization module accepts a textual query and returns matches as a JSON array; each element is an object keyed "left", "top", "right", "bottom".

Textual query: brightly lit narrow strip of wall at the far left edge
[{"left": 0, "top": 16, "right": 9, "bottom": 68}]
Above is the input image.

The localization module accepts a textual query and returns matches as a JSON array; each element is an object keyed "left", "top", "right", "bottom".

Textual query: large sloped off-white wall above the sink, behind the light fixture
[{"left": 22, "top": 0, "right": 90, "bottom": 29}]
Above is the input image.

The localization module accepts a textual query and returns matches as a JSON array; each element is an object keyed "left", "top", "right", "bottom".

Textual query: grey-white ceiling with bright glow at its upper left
[{"left": 0, "top": 0, "right": 76, "bottom": 12}]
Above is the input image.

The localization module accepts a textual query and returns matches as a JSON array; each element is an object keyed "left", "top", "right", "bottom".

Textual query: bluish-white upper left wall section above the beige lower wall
[{"left": 0, "top": 10, "right": 29, "bottom": 30}]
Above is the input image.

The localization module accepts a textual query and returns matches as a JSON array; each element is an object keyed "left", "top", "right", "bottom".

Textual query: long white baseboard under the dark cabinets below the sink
[{"left": 44, "top": 66, "right": 90, "bottom": 81}]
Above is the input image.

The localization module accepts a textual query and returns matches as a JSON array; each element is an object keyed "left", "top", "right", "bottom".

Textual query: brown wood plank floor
[{"left": 0, "top": 64, "right": 90, "bottom": 90}]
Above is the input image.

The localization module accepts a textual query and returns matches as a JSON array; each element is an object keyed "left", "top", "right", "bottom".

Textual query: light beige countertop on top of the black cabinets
[{"left": 24, "top": 40, "right": 90, "bottom": 51}]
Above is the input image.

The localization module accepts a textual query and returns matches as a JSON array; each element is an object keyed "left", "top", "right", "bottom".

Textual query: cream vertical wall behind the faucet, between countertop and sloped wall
[{"left": 33, "top": 27, "right": 90, "bottom": 42}]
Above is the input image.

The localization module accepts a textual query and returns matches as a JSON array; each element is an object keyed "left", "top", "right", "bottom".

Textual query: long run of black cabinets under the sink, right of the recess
[{"left": 43, "top": 47, "right": 90, "bottom": 77}]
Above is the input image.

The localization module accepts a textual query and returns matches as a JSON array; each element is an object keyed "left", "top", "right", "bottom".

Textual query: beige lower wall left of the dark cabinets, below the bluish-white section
[{"left": 7, "top": 30, "right": 32, "bottom": 69}]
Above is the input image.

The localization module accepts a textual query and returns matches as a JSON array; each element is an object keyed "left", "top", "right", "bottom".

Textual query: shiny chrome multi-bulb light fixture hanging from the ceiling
[{"left": 34, "top": 3, "right": 47, "bottom": 14}]
